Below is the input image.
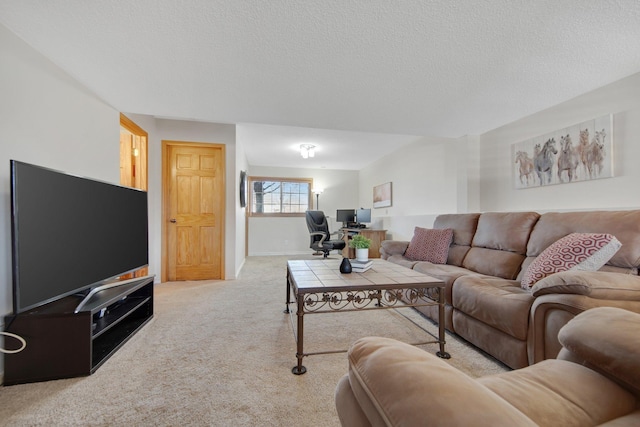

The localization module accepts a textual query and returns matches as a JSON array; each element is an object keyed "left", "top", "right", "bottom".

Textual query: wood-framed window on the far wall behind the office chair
[{"left": 249, "top": 177, "right": 313, "bottom": 216}]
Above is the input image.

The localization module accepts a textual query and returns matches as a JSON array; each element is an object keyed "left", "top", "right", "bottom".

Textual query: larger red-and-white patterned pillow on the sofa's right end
[{"left": 520, "top": 233, "right": 622, "bottom": 290}]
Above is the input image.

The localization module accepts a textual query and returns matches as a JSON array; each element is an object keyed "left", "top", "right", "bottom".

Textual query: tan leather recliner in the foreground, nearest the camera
[{"left": 335, "top": 307, "right": 640, "bottom": 427}]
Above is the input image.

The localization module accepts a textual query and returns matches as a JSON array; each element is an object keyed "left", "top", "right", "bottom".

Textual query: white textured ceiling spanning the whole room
[{"left": 0, "top": 0, "right": 640, "bottom": 169}]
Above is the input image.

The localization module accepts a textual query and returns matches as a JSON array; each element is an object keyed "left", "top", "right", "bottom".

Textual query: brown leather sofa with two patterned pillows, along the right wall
[{"left": 380, "top": 210, "right": 640, "bottom": 369}]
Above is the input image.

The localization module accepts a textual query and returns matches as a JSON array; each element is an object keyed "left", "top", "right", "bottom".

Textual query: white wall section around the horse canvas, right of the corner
[{"left": 480, "top": 74, "right": 640, "bottom": 211}]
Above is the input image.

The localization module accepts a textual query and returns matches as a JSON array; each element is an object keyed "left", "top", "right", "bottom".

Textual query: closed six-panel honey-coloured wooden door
[{"left": 163, "top": 141, "right": 225, "bottom": 281}]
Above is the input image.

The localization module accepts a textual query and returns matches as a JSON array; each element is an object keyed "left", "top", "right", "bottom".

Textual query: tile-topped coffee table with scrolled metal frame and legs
[{"left": 284, "top": 259, "right": 451, "bottom": 375}]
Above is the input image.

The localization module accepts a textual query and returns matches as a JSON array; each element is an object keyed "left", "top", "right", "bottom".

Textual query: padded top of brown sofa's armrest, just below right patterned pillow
[{"left": 531, "top": 271, "right": 640, "bottom": 301}]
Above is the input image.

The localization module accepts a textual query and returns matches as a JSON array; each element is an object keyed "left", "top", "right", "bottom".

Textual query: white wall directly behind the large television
[{"left": 0, "top": 26, "right": 120, "bottom": 378}]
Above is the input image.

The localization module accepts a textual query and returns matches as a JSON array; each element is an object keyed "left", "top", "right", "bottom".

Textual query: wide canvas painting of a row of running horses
[{"left": 511, "top": 115, "right": 613, "bottom": 188}]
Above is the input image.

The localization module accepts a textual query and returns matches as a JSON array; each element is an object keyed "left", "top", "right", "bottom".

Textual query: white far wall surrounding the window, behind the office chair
[{"left": 249, "top": 166, "right": 359, "bottom": 256}]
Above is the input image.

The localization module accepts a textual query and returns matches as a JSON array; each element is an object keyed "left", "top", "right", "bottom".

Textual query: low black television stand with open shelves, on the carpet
[{"left": 4, "top": 276, "right": 153, "bottom": 385}]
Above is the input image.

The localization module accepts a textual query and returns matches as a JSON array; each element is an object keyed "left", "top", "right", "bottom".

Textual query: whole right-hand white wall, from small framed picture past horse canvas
[{"left": 359, "top": 74, "right": 640, "bottom": 240}]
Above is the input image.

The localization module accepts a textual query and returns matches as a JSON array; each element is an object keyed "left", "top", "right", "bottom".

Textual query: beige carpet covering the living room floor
[{"left": 0, "top": 257, "right": 507, "bottom": 426}]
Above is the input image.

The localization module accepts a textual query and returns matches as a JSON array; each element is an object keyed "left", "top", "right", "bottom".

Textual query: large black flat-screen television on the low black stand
[{"left": 11, "top": 160, "right": 149, "bottom": 314}]
